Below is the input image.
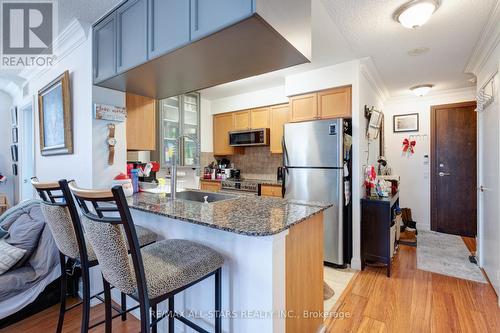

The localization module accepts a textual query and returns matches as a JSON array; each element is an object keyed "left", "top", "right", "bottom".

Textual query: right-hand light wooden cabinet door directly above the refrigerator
[{"left": 318, "top": 87, "right": 352, "bottom": 119}]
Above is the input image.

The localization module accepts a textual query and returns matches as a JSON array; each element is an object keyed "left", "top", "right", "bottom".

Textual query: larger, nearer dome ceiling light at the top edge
[{"left": 394, "top": 0, "right": 439, "bottom": 29}]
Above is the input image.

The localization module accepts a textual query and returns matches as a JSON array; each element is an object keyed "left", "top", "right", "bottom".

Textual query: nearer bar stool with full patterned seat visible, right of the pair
[{"left": 69, "top": 182, "right": 224, "bottom": 333}]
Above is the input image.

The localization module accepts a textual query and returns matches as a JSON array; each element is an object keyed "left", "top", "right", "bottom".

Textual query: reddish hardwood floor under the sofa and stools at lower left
[{"left": 0, "top": 299, "right": 140, "bottom": 333}]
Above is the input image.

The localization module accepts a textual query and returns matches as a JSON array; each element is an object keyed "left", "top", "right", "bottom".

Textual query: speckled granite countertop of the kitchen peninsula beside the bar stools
[{"left": 127, "top": 192, "right": 333, "bottom": 236}]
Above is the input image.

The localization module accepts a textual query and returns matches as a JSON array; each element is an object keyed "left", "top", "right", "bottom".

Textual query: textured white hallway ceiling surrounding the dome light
[{"left": 323, "top": 0, "right": 497, "bottom": 96}]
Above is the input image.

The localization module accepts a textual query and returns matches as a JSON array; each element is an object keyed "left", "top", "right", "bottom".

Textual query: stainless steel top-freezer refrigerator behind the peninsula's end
[{"left": 283, "top": 119, "right": 345, "bottom": 266}]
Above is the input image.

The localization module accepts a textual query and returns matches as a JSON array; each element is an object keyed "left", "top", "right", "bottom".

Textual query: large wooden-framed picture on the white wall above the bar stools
[{"left": 38, "top": 71, "right": 73, "bottom": 156}]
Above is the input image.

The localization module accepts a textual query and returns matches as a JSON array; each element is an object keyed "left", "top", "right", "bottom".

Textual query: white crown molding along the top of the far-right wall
[{"left": 464, "top": 1, "right": 500, "bottom": 76}]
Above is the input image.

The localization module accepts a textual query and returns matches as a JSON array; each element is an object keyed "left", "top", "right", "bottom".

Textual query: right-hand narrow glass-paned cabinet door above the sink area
[{"left": 182, "top": 93, "right": 200, "bottom": 166}]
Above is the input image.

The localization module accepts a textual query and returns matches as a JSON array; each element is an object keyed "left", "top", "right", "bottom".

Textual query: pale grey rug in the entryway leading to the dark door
[{"left": 417, "top": 230, "right": 486, "bottom": 283}]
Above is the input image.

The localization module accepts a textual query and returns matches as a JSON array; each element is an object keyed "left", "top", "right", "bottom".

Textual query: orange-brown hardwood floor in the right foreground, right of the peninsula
[{"left": 326, "top": 243, "right": 500, "bottom": 333}]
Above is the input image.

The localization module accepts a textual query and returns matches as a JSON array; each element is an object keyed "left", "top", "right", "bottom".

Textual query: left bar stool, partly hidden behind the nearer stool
[{"left": 31, "top": 177, "right": 158, "bottom": 333}]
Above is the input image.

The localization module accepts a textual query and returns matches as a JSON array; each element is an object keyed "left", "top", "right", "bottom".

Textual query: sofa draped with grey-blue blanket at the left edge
[{"left": 0, "top": 200, "right": 61, "bottom": 328}]
